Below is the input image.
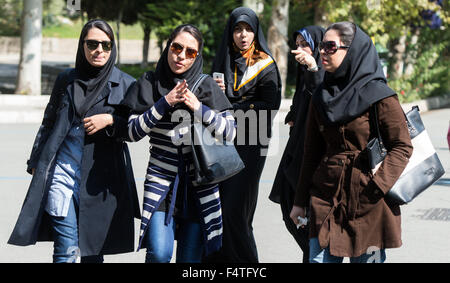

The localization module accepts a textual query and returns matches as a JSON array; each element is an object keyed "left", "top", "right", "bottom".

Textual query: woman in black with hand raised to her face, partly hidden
[{"left": 269, "top": 26, "right": 325, "bottom": 262}]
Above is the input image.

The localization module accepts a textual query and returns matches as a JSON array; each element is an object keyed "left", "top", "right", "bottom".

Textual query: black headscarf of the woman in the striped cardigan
[{"left": 122, "top": 24, "right": 231, "bottom": 113}]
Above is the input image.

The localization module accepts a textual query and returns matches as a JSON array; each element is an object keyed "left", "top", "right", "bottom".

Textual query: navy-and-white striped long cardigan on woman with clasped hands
[{"left": 128, "top": 97, "right": 236, "bottom": 254}]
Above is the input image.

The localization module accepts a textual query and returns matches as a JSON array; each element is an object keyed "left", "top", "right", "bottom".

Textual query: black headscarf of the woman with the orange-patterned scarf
[{"left": 212, "top": 7, "right": 281, "bottom": 97}]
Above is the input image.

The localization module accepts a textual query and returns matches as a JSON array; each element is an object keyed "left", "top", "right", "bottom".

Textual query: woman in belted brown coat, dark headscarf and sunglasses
[{"left": 290, "top": 22, "right": 412, "bottom": 262}]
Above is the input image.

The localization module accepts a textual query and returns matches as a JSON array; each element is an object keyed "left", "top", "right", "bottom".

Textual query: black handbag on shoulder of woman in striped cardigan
[{"left": 191, "top": 74, "right": 245, "bottom": 185}]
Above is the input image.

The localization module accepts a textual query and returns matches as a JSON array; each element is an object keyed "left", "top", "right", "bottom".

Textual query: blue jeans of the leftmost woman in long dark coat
[{"left": 50, "top": 197, "right": 103, "bottom": 263}]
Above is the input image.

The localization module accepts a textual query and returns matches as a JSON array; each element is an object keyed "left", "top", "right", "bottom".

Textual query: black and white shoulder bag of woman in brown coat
[{"left": 367, "top": 105, "right": 445, "bottom": 204}]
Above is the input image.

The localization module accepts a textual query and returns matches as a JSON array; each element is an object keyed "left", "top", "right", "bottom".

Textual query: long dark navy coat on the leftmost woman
[{"left": 8, "top": 68, "right": 140, "bottom": 256}]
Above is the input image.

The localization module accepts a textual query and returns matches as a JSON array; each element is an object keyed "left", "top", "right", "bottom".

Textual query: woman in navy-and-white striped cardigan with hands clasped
[{"left": 124, "top": 25, "right": 235, "bottom": 262}]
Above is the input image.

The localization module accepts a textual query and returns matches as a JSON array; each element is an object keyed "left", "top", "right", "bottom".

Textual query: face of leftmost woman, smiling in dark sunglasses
[{"left": 83, "top": 27, "right": 111, "bottom": 67}]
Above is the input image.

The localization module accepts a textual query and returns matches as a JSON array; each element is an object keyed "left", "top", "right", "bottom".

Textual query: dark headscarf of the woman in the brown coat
[{"left": 313, "top": 23, "right": 395, "bottom": 124}]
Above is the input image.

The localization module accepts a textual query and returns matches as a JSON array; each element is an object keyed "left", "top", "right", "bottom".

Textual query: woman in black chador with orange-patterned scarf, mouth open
[{"left": 211, "top": 7, "right": 281, "bottom": 262}]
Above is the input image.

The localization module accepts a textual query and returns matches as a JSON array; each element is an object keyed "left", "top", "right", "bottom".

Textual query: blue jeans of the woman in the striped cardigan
[{"left": 144, "top": 211, "right": 203, "bottom": 263}]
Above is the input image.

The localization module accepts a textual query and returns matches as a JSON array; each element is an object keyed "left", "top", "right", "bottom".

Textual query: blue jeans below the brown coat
[{"left": 309, "top": 238, "right": 386, "bottom": 263}]
